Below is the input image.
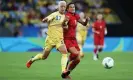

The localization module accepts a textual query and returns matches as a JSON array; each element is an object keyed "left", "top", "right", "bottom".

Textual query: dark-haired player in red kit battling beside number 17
[{"left": 62, "top": 3, "right": 89, "bottom": 78}]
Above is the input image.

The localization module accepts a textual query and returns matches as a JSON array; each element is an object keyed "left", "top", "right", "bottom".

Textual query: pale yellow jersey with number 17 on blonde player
[{"left": 47, "top": 11, "right": 65, "bottom": 38}]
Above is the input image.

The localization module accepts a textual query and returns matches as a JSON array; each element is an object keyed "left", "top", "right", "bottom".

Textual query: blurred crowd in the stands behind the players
[{"left": 0, "top": 0, "right": 122, "bottom": 37}]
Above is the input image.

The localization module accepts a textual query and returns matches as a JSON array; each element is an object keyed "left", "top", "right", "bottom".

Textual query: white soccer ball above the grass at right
[{"left": 102, "top": 57, "right": 114, "bottom": 69}]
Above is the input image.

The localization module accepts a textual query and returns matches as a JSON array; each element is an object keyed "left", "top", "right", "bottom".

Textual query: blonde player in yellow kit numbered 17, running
[{"left": 26, "top": 1, "right": 67, "bottom": 78}]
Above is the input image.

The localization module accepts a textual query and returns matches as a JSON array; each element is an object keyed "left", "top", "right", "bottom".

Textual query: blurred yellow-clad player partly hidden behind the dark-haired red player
[{"left": 76, "top": 12, "right": 89, "bottom": 58}]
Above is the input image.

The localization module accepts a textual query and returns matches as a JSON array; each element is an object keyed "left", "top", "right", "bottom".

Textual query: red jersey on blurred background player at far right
[{"left": 93, "top": 20, "right": 106, "bottom": 35}]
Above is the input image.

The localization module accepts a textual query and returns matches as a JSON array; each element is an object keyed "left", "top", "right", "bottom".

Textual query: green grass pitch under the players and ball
[{"left": 0, "top": 52, "right": 133, "bottom": 80}]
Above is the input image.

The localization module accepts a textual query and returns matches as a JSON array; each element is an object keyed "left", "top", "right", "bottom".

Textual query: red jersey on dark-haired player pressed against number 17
[{"left": 64, "top": 12, "right": 80, "bottom": 39}]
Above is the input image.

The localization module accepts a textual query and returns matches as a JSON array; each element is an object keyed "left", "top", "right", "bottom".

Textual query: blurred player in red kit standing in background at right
[{"left": 92, "top": 13, "right": 107, "bottom": 60}]
